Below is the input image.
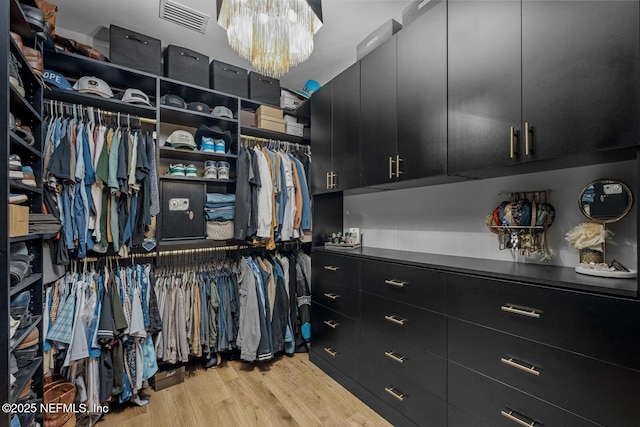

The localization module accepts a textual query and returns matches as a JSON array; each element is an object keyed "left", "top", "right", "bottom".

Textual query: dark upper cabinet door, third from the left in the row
[{"left": 358, "top": 36, "right": 397, "bottom": 186}]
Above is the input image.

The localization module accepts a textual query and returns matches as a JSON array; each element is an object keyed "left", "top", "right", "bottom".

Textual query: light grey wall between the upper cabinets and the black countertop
[{"left": 344, "top": 160, "right": 638, "bottom": 269}]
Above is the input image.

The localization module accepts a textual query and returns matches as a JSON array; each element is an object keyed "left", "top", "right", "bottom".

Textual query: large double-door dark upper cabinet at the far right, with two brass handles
[{"left": 448, "top": 0, "right": 640, "bottom": 175}]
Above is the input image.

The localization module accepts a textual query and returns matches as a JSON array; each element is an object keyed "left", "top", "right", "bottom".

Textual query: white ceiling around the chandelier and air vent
[{"left": 50, "top": 0, "right": 411, "bottom": 89}]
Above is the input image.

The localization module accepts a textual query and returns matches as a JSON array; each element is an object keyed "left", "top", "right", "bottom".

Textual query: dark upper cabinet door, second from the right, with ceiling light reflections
[{"left": 448, "top": 0, "right": 521, "bottom": 173}]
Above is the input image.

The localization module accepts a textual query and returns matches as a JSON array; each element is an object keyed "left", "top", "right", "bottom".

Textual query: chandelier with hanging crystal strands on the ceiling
[{"left": 217, "top": 0, "right": 322, "bottom": 78}]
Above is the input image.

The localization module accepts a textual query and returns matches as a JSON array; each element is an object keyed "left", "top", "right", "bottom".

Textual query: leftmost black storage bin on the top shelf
[{"left": 109, "top": 25, "right": 162, "bottom": 75}]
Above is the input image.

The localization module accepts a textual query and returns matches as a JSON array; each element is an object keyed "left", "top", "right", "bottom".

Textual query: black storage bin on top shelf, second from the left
[{"left": 164, "top": 45, "right": 209, "bottom": 87}]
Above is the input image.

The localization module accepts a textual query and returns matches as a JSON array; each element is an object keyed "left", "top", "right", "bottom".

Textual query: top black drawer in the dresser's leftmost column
[{"left": 311, "top": 252, "right": 360, "bottom": 289}]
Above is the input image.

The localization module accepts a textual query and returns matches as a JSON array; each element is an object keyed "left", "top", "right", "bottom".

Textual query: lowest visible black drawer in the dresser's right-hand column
[{"left": 448, "top": 362, "right": 597, "bottom": 427}]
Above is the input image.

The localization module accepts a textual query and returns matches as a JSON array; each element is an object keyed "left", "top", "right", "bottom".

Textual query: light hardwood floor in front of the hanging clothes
[{"left": 97, "top": 353, "right": 390, "bottom": 427}]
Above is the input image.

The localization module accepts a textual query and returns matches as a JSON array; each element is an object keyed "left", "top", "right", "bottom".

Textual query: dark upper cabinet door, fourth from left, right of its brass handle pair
[{"left": 397, "top": 0, "right": 447, "bottom": 179}]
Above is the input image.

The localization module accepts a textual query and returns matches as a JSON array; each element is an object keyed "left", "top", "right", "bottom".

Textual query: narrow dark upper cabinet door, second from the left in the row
[{"left": 332, "top": 62, "right": 360, "bottom": 191}]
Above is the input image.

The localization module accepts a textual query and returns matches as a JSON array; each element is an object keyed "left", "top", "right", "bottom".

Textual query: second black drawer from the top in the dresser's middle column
[{"left": 360, "top": 292, "right": 447, "bottom": 357}]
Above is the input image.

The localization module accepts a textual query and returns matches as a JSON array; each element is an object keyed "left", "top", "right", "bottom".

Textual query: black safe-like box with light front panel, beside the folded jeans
[{"left": 160, "top": 181, "right": 206, "bottom": 240}]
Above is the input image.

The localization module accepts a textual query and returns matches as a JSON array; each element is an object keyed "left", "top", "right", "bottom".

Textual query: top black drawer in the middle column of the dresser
[{"left": 361, "top": 260, "right": 447, "bottom": 313}]
